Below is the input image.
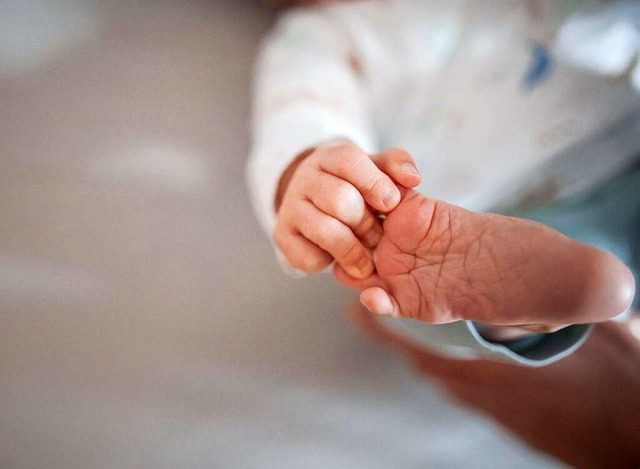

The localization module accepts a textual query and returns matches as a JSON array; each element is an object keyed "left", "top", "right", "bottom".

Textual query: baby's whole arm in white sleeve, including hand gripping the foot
[{"left": 247, "top": 9, "right": 420, "bottom": 278}]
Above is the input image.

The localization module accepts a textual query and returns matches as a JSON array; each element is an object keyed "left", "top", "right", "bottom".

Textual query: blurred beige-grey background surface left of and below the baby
[{"left": 0, "top": 0, "right": 558, "bottom": 468}]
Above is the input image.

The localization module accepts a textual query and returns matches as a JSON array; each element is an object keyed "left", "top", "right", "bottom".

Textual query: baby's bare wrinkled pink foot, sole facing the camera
[{"left": 334, "top": 190, "right": 635, "bottom": 332}]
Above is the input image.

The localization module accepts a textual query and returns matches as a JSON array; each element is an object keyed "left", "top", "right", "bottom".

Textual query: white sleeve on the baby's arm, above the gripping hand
[{"left": 247, "top": 9, "right": 375, "bottom": 243}]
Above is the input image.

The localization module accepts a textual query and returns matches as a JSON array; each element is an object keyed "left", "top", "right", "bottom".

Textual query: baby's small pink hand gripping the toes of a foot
[{"left": 274, "top": 142, "right": 421, "bottom": 278}]
